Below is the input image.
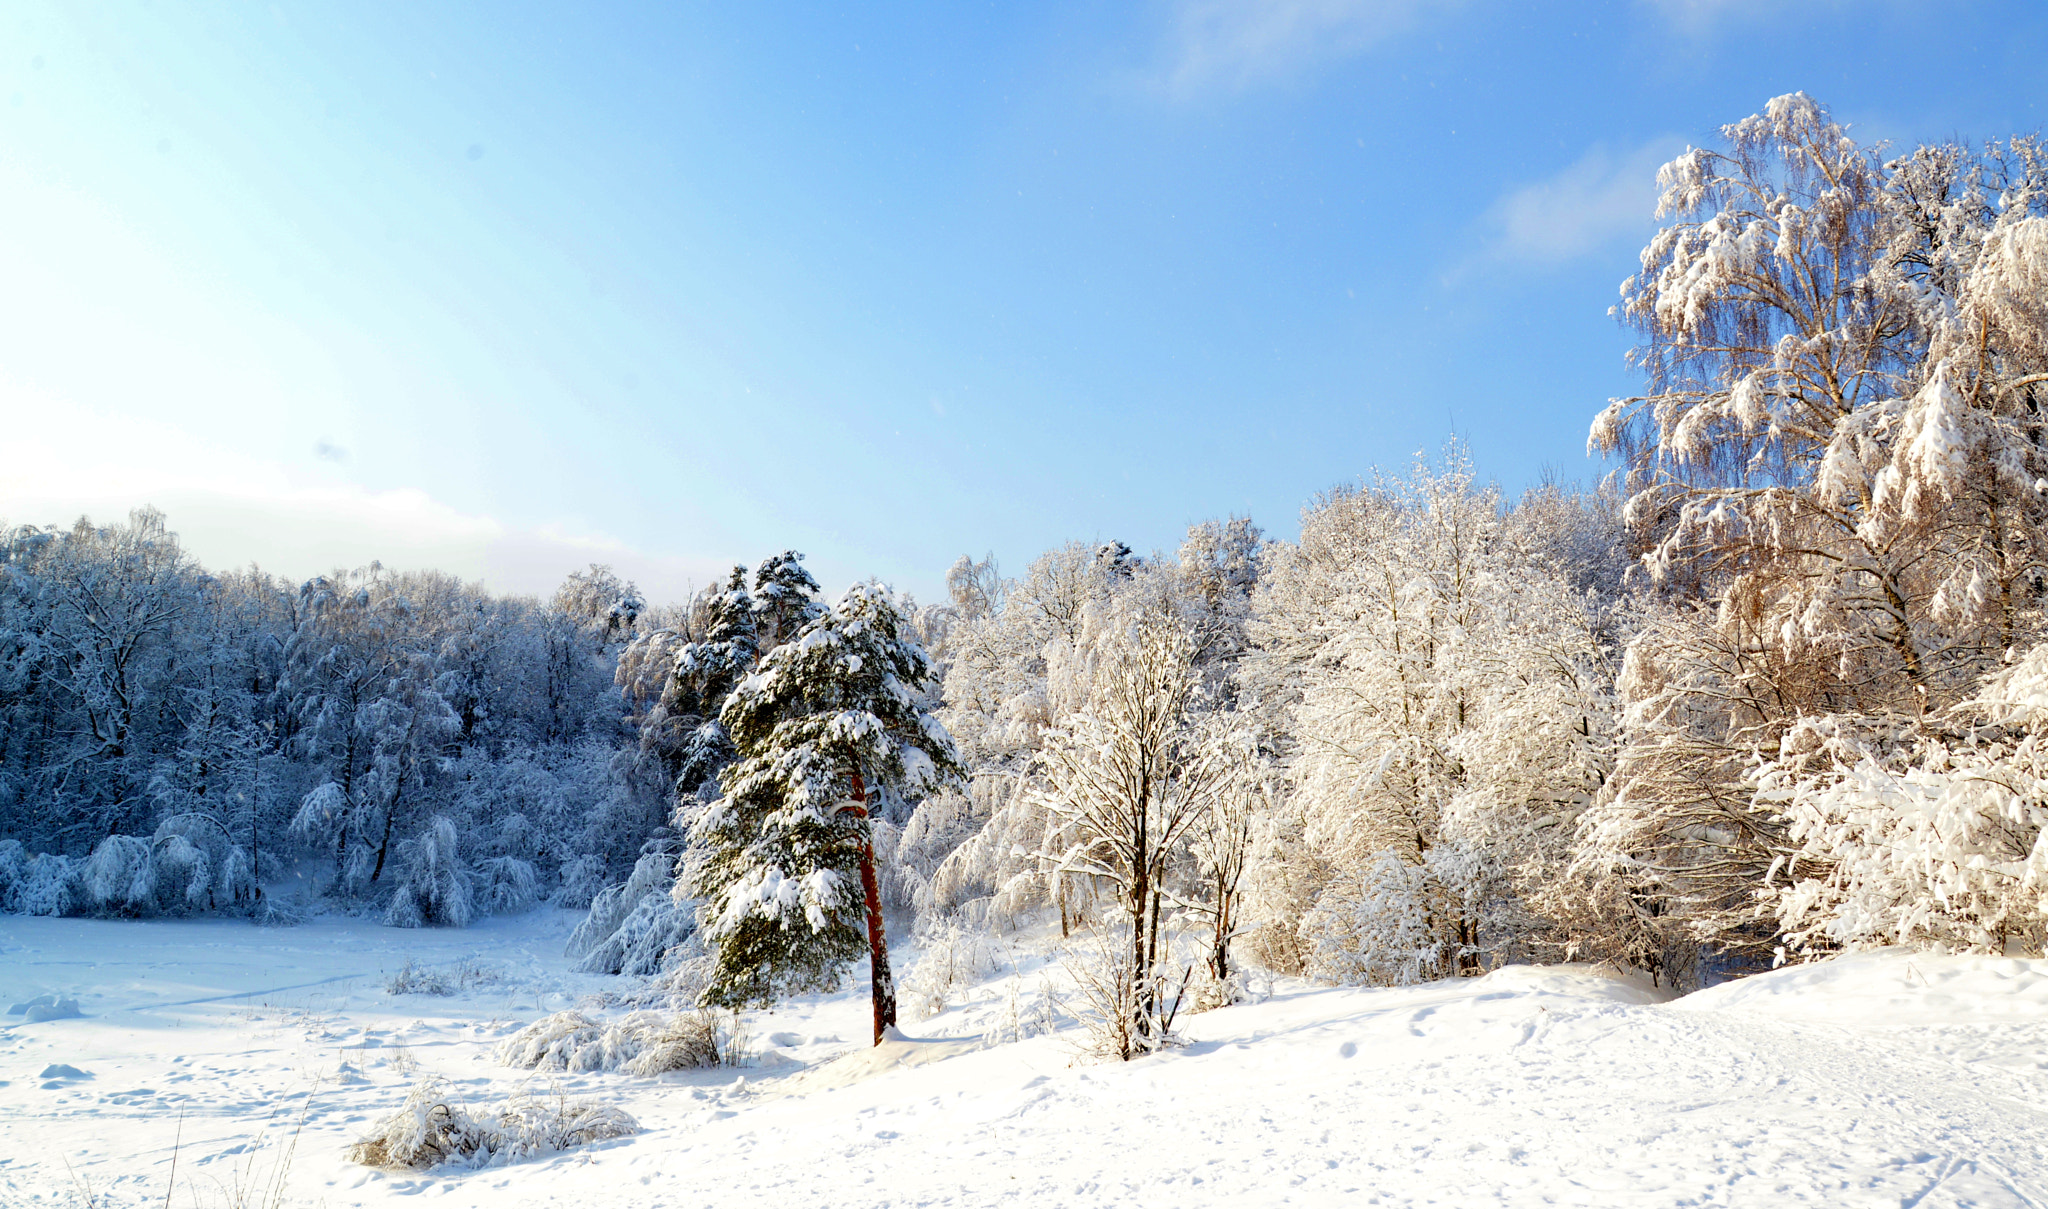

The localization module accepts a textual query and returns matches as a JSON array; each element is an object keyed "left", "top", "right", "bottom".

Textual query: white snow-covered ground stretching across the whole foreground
[{"left": 0, "top": 912, "right": 2048, "bottom": 1209}]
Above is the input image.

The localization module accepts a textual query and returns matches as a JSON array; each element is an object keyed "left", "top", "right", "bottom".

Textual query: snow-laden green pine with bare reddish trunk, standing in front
[{"left": 678, "top": 581, "right": 961, "bottom": 1043}]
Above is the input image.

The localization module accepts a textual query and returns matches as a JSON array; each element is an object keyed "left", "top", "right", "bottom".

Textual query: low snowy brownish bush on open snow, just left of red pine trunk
[{"left": 498, "top": 1008, "right": 745, "bottom": 1076}]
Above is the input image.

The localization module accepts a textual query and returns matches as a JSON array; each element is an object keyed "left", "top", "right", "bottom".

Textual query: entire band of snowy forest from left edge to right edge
[{"left": 0, "top": 94, "right": 2048, "bottom": 1032}]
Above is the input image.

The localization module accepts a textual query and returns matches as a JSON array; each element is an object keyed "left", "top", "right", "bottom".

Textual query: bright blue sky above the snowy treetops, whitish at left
[{"left": 0, "top": 0, "right": 2048, "bottom": 598}]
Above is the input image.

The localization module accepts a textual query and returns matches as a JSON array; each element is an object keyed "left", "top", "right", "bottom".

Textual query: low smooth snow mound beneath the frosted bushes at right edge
[{"left": 1673, "top": 949, "right": 2048, "bottom": 1025}]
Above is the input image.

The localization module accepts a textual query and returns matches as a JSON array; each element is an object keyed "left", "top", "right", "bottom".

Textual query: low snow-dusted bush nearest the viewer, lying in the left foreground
[{"left": 348, "top": 1078, "right": 639, "bottom": 1170}]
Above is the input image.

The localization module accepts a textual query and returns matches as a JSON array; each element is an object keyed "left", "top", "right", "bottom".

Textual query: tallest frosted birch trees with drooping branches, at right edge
[{"left": 1554, "top": 94, "right": 2048, "bottom": 975}]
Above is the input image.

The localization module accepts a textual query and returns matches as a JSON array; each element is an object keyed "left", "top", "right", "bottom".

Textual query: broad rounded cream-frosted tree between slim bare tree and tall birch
[{"left": 1251, "top": 455, "right": 1616, "bottom": 979}]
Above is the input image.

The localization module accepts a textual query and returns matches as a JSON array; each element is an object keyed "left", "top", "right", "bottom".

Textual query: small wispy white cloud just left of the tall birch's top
[{"left": 1485, "top": 137, "right": 1686, "bottom": 264}]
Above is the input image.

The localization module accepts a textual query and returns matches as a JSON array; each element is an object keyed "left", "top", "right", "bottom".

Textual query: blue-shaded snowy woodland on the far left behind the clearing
[{"left": 0, "top": 510, "right": 670, "bottom": 918}]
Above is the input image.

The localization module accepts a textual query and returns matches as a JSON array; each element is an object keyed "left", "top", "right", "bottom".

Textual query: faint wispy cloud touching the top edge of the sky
[{"left": 1165, "top": 0, "right": 1462, "bottom": 96}]
